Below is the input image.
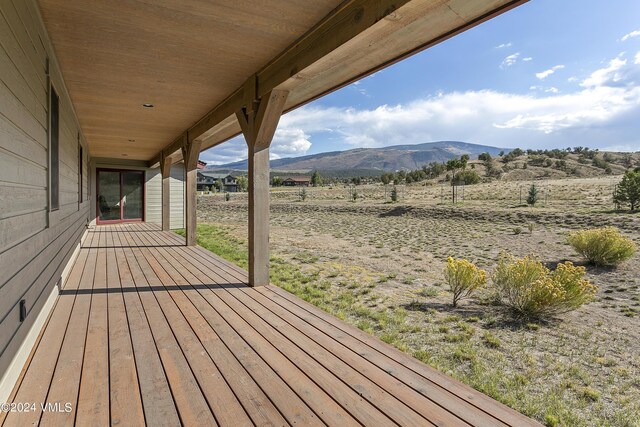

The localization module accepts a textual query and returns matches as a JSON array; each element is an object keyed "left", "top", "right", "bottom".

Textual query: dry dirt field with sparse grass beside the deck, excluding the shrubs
[{"left": 198, "top": 177, "right": 640, "bottom": 426}]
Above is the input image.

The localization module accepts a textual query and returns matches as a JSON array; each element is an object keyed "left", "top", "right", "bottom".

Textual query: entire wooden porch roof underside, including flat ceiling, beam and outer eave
[{"left": 39, "top": 0, "right": 526, "bottom": 164}]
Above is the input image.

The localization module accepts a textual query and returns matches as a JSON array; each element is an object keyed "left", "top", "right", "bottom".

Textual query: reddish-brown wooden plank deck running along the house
[{"left": 0, "top": 223, "right": 537, "bottom": 426}]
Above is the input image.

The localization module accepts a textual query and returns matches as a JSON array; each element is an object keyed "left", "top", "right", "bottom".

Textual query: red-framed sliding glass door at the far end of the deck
[{"left": 97, "top": 169, "right": 144, "bottom": 223}]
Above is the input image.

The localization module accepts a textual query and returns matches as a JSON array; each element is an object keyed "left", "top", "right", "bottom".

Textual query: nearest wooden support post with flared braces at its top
[{"left": 236, "top": 90, "right": 288, "bottom": 286}]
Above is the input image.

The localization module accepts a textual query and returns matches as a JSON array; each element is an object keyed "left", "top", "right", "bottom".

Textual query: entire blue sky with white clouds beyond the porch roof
[{"left": 201, "top": 0, "right": 640, "bottom": 164}]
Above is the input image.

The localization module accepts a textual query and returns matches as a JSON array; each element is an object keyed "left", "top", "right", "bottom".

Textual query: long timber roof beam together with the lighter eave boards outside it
[{"left": 151, "top": 0, "right": 528, "bottom": 164}]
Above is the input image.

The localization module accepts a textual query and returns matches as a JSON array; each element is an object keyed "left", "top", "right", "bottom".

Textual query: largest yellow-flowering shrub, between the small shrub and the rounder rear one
[{"left": 493, "top": 254, "right": 597, "bottom": 317}]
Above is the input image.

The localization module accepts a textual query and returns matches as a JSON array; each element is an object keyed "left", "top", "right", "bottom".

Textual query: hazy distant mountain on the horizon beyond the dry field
[{"left": 207, "top": 141, "right": 510, "bottom": 171}]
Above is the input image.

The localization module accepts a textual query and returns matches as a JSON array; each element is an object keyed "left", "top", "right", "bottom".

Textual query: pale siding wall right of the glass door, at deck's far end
[{"left": 145, "top": 163, "right": 185, "bottom": 230}]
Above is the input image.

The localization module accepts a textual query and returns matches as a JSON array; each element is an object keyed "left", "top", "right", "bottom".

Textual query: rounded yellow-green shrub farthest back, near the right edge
[{"left": 567, "top": 227, "right": 636, "bottom": 266}]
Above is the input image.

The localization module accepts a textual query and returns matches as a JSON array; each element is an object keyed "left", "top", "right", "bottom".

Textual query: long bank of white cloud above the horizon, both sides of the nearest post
[{"left": 202, "top": 57, "right": 640, "bottom": 163}]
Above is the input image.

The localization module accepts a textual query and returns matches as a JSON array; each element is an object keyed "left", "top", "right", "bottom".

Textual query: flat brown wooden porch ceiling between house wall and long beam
[{"left": 39, "top": 0, "right": 340, "bottom": 160}]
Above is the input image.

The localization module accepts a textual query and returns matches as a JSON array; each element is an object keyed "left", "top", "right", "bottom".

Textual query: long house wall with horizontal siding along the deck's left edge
[{"left": 0, "top": 0, "right": 91, "bottom": 394}]
